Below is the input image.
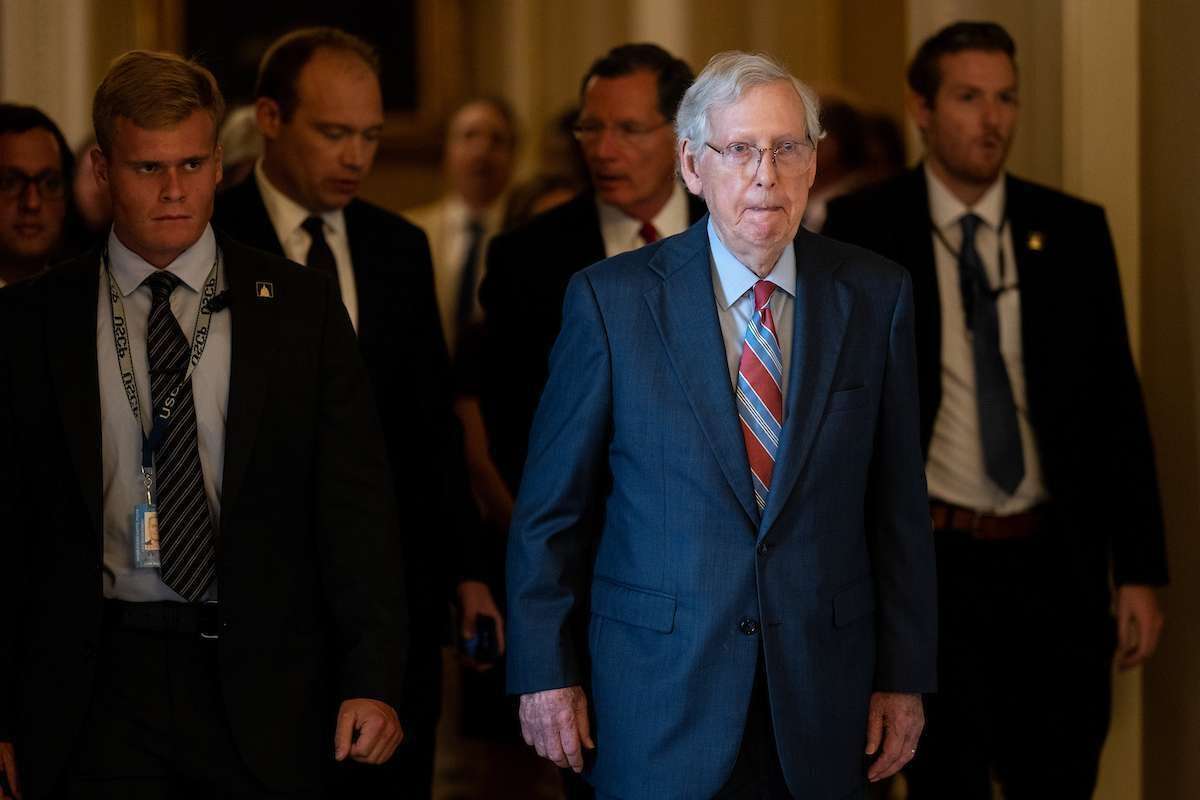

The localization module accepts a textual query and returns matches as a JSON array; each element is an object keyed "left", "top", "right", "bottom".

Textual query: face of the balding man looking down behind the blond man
[{"left": 257, "top": 48, "right": 383, "bottom": 213}]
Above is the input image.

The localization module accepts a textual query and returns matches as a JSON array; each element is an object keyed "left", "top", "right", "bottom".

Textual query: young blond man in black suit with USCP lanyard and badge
[{"left": 0, "top": 52, "right": 404, "bottom": 798}]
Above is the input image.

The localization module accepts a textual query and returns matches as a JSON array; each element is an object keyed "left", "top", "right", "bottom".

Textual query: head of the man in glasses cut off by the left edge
[{"left": 0, "top": 103, "right": 74, "bottom": 287}]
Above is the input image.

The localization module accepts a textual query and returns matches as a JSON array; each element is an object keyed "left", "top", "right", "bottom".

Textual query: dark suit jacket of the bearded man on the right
[{"left": 823, "top": 167, "right": 1166, "bottom": 593}]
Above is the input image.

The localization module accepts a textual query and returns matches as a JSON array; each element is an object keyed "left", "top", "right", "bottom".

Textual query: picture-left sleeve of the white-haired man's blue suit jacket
[{"left": 508, "top": 273, "right": 612, "bottom": 694}]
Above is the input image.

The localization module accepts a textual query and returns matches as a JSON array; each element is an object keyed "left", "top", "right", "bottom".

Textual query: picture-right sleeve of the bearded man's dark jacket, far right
[{"left": 1082, "top": 207, "right": 1166, "bottom": 587}]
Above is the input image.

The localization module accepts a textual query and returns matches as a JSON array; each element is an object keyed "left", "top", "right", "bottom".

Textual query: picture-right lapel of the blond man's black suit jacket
[{"left": 221, "top": 240, "right": 287, "bottom": 518}]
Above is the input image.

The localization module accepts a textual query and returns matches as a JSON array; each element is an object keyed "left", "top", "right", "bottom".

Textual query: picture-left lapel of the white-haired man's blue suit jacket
[{"left": 646, "top": 218, "right": 758, "bottom": 524}]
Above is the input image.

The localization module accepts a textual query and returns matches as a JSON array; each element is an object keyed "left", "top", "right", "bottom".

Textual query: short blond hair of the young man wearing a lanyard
[{"left": 91, "top": 50, "right": 224, "bottom": 155}]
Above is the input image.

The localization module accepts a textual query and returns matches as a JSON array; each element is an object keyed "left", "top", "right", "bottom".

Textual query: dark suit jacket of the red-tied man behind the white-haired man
[{"left": 479, "top": 191, "right": 706, "bottom": 491}]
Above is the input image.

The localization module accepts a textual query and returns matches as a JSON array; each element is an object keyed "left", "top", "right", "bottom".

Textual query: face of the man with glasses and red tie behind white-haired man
[{"left": 575, "top": 70, "right": 676, "bottom": 222}]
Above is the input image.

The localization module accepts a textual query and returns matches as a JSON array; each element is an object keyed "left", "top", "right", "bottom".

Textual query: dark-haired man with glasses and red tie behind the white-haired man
[{"left": 480, "top": 44, "right": 704, "bottom": 492}]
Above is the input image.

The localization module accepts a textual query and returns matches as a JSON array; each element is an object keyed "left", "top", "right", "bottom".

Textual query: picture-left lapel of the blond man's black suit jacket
[{"left": 46, "top": 252, "right": 103, "bottom": 536}]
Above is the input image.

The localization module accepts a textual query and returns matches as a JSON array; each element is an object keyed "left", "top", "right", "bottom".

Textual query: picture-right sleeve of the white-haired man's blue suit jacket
[{"left": 866, "top": 272, "right": 937, "bottom": 692}]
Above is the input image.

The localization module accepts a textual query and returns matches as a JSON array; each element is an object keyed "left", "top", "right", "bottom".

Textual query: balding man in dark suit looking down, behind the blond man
[{"left": 214, "top": 28, "right": 503, "bottom": 798}]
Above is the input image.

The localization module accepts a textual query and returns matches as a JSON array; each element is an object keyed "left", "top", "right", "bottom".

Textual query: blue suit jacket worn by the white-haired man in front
[{"left": 508, "top": 218, "right": 936, "bottom": 799}]
